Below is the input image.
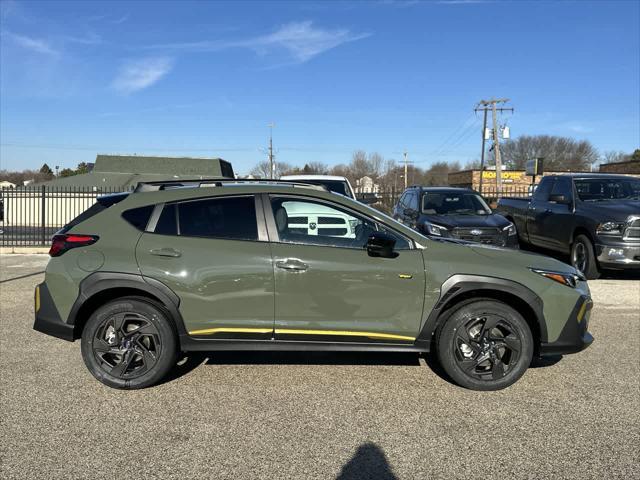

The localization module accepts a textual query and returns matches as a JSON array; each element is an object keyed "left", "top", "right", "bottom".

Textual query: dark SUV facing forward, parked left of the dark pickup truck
[{"left": 393, "top": 186, "right": 518, "bottom": 248}]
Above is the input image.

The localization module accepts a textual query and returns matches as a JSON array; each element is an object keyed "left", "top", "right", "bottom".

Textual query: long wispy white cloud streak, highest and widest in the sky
[{"left": 142, "top": 21, "right": 370, "bottom": 63}]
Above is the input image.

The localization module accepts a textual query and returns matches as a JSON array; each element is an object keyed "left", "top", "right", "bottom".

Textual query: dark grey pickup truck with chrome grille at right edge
[{"left": 497, "top": 173, "right": 640, "bottom": 279}]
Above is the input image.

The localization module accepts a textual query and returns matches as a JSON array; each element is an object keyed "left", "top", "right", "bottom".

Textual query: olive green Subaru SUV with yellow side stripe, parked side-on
[{"left": 34, "top": 181, "right": 593, "bottom": 390}]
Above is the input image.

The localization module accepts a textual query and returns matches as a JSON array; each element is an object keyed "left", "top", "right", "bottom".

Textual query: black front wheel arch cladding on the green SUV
[{"left": 416, "top": 275, "right": 548, "bottom": 354}]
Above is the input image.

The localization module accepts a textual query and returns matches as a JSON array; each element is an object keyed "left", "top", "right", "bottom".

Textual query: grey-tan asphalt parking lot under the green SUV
[{"left": 0, "top": 255, "right": 640, "bottom": 480}]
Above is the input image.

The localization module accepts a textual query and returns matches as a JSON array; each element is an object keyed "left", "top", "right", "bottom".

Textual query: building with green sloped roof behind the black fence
[{"left": 39, "top": 155, "right": 234, "bottom": 191}]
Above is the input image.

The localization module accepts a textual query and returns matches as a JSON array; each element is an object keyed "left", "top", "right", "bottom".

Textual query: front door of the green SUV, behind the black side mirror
[{"left": 264, "top": 195, "right": 425, "bottom": 343}]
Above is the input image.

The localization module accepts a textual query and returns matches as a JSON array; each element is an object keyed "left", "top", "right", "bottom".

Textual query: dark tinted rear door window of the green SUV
[{"left": 176, "top": 196, "right": 258, "bottom": 240}]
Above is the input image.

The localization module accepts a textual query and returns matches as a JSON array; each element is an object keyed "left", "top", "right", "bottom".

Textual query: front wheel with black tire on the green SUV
[{"left": 436, "top": 299, "right": 533, "bottom": 390}]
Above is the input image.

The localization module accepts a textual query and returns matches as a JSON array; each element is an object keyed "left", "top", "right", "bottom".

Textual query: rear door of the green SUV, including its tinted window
[{"left": 136, "top": 195, "right": 274, "bottom": 340}]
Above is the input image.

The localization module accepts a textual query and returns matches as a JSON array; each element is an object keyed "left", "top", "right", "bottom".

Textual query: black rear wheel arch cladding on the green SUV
[{"left": 67, "top": 272, "right": 186, "bottom": 339}]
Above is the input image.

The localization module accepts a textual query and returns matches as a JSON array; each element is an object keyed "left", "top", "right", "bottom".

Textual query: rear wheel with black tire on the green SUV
[{"left": 81, "top": 297, "right": 177, "bottom": 390}]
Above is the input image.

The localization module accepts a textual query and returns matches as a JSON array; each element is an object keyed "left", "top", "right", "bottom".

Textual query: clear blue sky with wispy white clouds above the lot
[{"left": 0, "top": 0, "right": 640, "bottom": 173}]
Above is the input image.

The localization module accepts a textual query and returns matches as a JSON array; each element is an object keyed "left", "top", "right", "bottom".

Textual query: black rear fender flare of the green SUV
[{"left": 67, "top": 272, "right": 186, "bottom": 335}]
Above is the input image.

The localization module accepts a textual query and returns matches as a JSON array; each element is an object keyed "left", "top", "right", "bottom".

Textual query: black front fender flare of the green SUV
[{"left": 416, "top": 274, "right": 548, "bottom": 350}]
